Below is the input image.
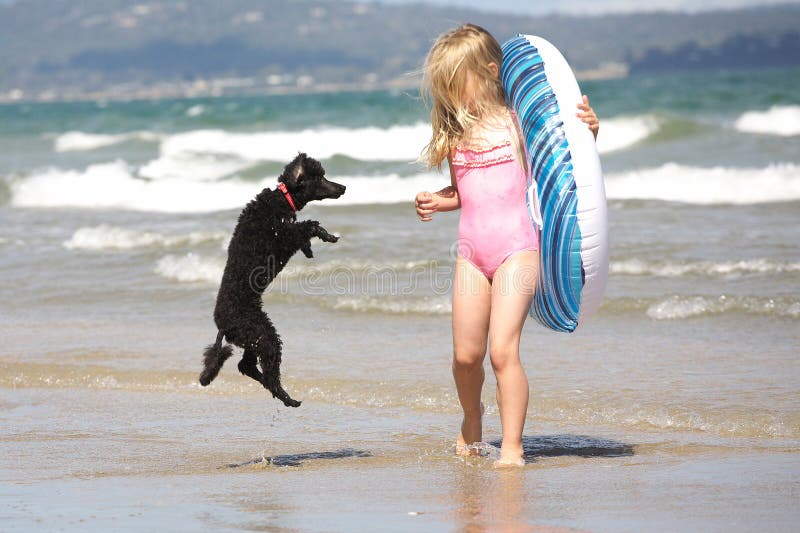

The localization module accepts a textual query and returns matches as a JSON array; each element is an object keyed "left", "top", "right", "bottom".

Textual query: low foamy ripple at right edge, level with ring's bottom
[{"left": 647, "top": 295, "right": 800, "bottom": 320}]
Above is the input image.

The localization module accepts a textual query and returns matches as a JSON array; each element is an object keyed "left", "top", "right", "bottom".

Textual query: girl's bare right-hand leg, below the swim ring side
[{"left": 489, "top": 251, "right": 539, "bottom": 465}]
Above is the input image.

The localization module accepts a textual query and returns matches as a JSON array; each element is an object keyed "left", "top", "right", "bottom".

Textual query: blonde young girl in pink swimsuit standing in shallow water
[{"left": 414, "top": 24, "right": 599, "bottom": 466}]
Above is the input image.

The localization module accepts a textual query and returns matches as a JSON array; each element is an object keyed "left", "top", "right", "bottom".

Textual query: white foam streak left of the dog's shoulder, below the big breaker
[{"left": 63, "top": 224, "right": 227, "bottom": 250}]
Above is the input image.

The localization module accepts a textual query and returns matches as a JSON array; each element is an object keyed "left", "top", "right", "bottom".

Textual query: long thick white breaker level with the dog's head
[{"left": 10, "top": 161, "right": 800, "bottom": 213}]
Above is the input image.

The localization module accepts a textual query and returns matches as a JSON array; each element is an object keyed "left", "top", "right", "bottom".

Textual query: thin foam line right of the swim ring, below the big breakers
[{"left": 609, "top": 259, "right": 800, "bottom": 278}]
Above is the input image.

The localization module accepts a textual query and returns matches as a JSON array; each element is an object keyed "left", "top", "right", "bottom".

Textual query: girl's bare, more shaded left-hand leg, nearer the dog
[{"left": 453, "top": 257, "right": 491, "bottom": 450}]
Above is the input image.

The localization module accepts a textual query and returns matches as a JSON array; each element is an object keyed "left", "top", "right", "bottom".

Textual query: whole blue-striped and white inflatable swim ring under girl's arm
[{"left": 501, "top": 35, "right": 608, "bottom": 332}]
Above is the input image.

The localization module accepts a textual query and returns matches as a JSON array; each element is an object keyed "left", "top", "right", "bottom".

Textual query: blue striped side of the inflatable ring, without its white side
[{"left": 501, "top": 36, "right": 584, "bottom": 332}]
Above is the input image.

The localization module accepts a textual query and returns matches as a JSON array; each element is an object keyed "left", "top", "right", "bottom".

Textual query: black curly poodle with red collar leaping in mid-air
[{"left": 200, "top": 154, "right": 345, "bottom": 407}]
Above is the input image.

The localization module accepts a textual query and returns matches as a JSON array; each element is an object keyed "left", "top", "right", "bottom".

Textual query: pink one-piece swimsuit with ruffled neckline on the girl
[{"left": 451, "top": 123, "right": 539, "bottom": 281}]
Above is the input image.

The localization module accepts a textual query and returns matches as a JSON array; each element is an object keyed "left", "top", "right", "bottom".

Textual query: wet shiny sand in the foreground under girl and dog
[{"left": 0, "top": 378, "right": 800, "bottom": 532}]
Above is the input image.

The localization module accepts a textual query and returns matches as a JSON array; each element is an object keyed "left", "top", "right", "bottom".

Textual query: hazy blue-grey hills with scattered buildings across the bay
[{"left": 0, "top": 0, "right": 800, "bottom": 98}]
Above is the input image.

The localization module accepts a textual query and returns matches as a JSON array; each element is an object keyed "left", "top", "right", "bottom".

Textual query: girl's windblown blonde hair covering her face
[{"left": 421, "top": 24, "right": 505, "bottom": 170}]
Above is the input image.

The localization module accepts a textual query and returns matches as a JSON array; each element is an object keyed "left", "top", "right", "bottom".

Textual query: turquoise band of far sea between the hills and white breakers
[{"left": 0, "top": 69, "right": 800, "bottom": 135}]
